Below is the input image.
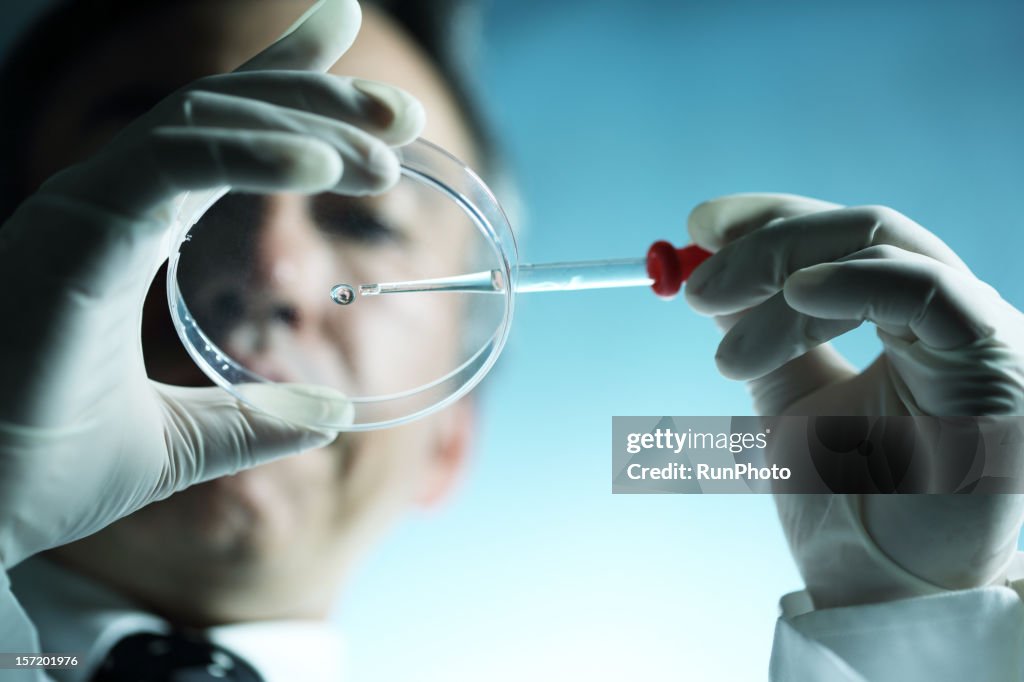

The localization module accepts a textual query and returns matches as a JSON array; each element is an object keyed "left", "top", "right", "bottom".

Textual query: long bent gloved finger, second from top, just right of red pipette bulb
[{"left": 686, "top": 200, "right": 969, "bottom": 314}]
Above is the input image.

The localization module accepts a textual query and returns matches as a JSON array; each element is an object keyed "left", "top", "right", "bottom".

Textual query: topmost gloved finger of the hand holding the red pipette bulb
[{"left": 686, "top": 193, "right": 843, "bottom": 252}]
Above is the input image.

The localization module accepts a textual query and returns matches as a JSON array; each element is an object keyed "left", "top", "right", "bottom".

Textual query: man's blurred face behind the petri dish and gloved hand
[{"left": 31, "top": 0, "right": 474, "bottom": 622}]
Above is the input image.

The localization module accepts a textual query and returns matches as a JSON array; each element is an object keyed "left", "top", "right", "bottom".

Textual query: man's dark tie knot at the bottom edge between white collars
[{"left": 91, "top": 632, "right": 263, "bottom": 682}]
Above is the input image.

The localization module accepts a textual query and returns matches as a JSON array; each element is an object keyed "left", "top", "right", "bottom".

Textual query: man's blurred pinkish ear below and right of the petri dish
[{"left": 416, "top": 397, "right": 476, "bottom": 508}]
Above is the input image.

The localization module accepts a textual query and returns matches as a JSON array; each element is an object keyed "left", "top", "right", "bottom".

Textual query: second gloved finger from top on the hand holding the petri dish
[{"left": 186, "top": 71, "right": 426, "bottom": 146}]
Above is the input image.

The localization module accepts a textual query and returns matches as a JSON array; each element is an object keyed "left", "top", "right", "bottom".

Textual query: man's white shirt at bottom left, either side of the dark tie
[{"left": 0, "top": 557, "right": 342, "bottom": 682}]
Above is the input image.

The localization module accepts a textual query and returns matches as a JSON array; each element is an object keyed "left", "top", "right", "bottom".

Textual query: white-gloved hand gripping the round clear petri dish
[{"left": 0, "top": 0, "right": 424, "bottom": 568}]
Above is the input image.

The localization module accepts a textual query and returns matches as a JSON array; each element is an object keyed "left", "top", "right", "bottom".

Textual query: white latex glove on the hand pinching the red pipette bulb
[{"left": 686, "top": 195, "right": 1024, "bottom": 606}]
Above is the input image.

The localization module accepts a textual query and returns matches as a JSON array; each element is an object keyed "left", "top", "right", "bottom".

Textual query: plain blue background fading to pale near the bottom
[{"left": 0, "top": 0, "right": 1024, "bottom": 681}]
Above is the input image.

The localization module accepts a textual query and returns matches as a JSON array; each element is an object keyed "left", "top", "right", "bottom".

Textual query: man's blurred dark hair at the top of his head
[{"left": 0, "top": 0, "right": 494, "bottom": 222}]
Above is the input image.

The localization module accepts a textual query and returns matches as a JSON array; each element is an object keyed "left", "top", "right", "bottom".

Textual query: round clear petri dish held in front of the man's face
[{"left": 167, "top": 139, "right": 518, "bottom": 431}]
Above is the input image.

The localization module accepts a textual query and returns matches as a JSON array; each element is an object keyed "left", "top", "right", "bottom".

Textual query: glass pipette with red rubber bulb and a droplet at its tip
[{"left": 331, "top": 242, "right": 711, "bottom": 305}]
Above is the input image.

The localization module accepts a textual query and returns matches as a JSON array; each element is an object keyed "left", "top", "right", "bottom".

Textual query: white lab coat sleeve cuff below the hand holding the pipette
[{"left": 770, "top": 496, "right": 1024, "bottom": 682}]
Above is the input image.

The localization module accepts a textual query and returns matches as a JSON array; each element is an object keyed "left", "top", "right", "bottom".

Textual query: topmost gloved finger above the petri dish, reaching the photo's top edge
[{"left": 236, "top": 0, "right": 362, "bottom": 72}]
